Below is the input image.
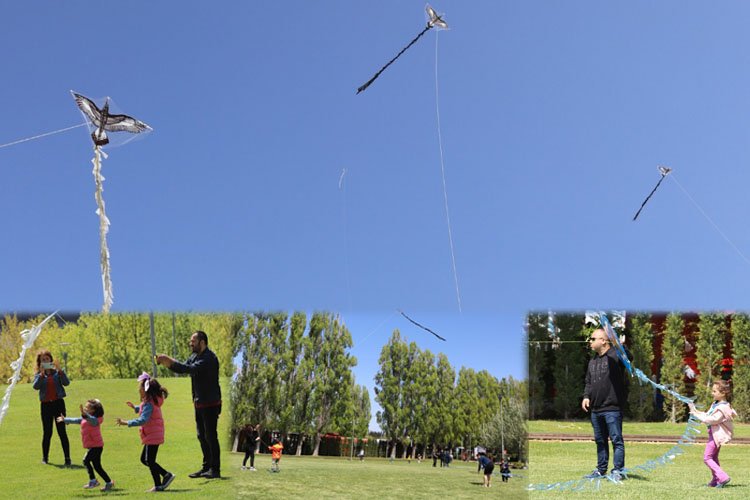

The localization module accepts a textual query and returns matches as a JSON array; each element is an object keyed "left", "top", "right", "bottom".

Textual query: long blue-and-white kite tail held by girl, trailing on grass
[{"left": 527, "top": 311, "right": 701, "bottom": 491}]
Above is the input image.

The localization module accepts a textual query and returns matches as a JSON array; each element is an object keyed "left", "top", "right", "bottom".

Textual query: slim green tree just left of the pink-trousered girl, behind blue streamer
[{"left": 660, "top": 313, "right": 686, "bottom": 423}]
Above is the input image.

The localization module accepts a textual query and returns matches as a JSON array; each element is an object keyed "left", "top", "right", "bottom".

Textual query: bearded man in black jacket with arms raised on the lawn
[{"left": 156, "top": 330, "right": 221, "bottom": 479}]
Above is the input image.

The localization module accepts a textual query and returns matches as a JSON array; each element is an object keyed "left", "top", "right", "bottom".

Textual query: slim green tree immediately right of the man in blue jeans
[{"left": 627, "top": 314, "right": 655, "bottom": 421}]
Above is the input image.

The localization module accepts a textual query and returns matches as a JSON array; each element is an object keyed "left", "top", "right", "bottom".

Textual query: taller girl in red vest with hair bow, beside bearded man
[{"left": 117, "top": 372, "right": 174, "bottom": 493}]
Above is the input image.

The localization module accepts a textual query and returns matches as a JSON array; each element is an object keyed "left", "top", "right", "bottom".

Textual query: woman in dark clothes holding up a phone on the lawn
[{"left": 32, "top": 349, "right": 71, "bottom": 467}]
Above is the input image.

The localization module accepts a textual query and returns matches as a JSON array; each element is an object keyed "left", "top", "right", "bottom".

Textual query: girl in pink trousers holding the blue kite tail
[{"left": 688, "top": 380, "right": 737, "bottom": 488}]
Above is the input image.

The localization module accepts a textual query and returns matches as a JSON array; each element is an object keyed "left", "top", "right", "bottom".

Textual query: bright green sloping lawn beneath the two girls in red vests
[{"left": 0, "top": 378, "right": 237, "bottom": 500}]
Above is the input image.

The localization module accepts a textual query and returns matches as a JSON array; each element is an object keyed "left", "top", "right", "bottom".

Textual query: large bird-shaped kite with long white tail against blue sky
[{"left": 71, "top": 90, "right": 152, "bottom": 313}]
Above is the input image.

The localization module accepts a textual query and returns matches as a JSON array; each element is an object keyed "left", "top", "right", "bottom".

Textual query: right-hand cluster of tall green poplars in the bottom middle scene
[{"left": 375, "top": 330, "right": 527, "bottom": 460}]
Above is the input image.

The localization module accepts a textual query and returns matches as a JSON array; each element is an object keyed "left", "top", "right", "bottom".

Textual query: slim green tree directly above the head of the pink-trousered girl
[{"left": 695, "top": 313, "right": 727, "bottom": 401}]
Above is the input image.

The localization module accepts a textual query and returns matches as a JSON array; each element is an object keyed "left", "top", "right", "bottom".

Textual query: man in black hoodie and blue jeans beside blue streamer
[{"left": 581, "top": 328, "right": 630, "bottom": 481}]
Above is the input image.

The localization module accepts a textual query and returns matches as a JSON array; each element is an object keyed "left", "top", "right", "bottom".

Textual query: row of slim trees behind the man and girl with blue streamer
[{"left": 527, "top": 313, "right": 750, "bottom": 422}]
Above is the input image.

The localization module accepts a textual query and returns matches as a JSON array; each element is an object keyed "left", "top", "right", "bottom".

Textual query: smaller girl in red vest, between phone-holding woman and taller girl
[{"left": 57, "top": 399, "right": 115, "bottom": 491}]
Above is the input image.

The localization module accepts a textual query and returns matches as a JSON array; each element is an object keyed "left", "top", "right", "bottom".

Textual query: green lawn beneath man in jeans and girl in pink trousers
[{"left": 529, "top": 440, "right": 750, "bottom": 500}]
